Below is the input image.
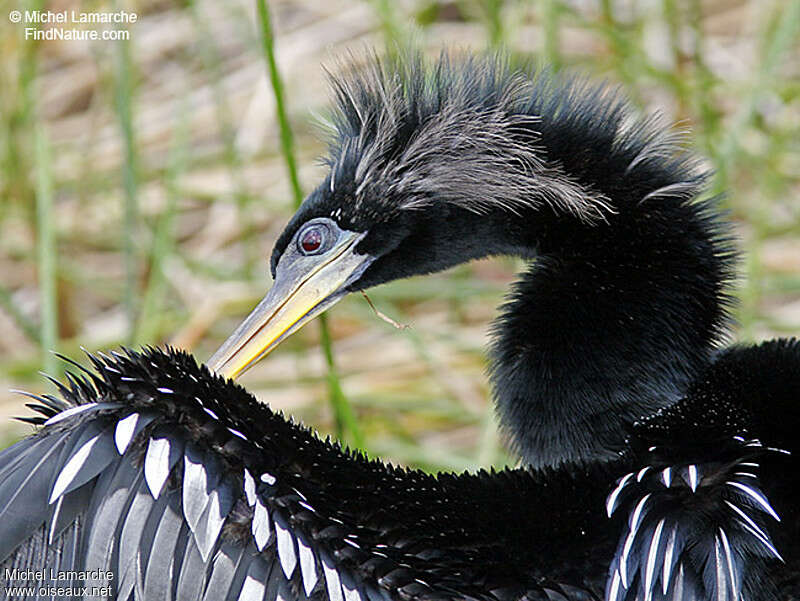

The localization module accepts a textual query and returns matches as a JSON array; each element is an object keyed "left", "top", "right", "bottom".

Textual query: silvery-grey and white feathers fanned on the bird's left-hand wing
[{"left": 0, "top": 350, "right": 396, "bottom": 601}]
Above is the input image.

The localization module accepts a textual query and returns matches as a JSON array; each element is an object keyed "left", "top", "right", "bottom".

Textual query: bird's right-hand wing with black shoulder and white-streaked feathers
[{"left": 607, "top": 340, "right": 800, "bottom": 601}]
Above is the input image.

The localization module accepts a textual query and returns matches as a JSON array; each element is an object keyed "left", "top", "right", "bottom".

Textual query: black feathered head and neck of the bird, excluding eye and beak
[{"left": 272, "top": 56, "right": 735, "bottom": 466}]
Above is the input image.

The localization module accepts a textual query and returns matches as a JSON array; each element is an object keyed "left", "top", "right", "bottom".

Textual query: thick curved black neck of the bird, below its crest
[{"left": 490, "top": 198, "right": 733, "bottom": 468}]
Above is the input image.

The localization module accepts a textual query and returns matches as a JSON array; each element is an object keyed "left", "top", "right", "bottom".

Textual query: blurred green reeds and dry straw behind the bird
[{"left": 0, "top": 0, "right": 800, "bottom": 470}]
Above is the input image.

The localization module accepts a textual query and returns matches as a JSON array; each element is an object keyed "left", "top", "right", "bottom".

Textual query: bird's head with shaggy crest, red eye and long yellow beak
[{"left": 209, "top": 53, "right": 644, "bottom": 377}]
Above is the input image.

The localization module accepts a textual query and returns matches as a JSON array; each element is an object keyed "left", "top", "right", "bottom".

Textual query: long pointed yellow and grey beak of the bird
[{"left": 207, "top": 231, "right": 375, "bottom": 378}]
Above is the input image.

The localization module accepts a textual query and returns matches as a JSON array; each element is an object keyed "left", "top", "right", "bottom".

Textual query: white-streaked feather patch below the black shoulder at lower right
[{"left": 606, "top": 439, "right": 783, "bottom": 601}]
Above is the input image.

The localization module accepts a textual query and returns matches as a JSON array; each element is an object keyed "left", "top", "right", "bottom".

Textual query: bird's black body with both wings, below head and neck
[{"left": 0, "top": 343, "right": 800, "bottom": 601}]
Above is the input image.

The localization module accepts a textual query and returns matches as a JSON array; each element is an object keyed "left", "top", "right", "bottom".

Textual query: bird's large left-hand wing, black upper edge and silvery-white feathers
[{"left": 0, "top": 350, "right": 616, "bottom": 601}]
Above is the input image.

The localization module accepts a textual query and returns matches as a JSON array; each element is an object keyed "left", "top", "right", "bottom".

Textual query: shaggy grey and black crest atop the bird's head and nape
[{"left": 282, "top": 53, "right": 705, "bottom": 231}]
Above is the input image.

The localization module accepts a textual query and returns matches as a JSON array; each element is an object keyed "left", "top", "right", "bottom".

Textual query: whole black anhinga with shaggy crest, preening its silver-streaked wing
[{"left": 0, "top": 55, "right": 800, "bottom": 601}]
